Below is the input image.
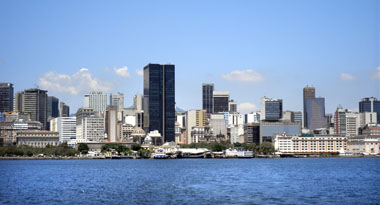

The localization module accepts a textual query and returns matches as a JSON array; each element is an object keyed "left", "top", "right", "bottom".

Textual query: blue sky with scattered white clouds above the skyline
[{"left": 0, "top": 0, "right": 380, "bottom": 113}]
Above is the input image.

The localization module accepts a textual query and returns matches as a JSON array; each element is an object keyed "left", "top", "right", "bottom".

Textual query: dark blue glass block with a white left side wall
[{"left": 260, "top": 96, "right": 282, "bottom": 121}]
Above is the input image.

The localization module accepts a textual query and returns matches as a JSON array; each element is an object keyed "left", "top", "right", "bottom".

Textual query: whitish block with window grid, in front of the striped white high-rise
[{"left": 76, "top": 108, "right": 104, "bottom": 142}]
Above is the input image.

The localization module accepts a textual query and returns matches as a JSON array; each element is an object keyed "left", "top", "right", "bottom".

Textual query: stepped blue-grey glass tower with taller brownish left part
[{"left": 303, "top": 87, "right": 327, "bottom": 130}]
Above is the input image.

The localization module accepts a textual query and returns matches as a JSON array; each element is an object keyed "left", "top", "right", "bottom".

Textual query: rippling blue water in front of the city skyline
[{"left": 0, "top": 158, "right": 380, "bottom": 204}]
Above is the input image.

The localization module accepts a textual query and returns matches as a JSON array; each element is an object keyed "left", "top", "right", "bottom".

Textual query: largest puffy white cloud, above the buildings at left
[{"left": 38, "top": 68, "right": 112, "bottom": 95}]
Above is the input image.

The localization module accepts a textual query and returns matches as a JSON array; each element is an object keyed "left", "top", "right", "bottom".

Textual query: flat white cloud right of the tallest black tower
[{"left": 222, "top": 69, "right": 265, "bottom": 83}]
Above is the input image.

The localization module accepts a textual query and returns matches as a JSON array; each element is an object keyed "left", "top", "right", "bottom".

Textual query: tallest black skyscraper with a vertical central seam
[{"left": 143, "top": 64, "right": 175, "bottom": 142}]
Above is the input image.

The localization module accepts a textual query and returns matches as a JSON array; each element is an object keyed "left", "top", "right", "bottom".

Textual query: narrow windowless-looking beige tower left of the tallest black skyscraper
[{"left": 106, "top": 106, "right": 120, "bottom": 142}]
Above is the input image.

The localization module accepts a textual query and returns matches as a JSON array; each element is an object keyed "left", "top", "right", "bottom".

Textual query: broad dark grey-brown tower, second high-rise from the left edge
[{"left": 22, "top": 88, "right": 47, "bottom": 129}]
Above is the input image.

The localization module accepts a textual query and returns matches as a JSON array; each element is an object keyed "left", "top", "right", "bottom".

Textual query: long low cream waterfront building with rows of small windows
[{"left": 272, "top": 134, "right": 347, "bottom": 154}]
